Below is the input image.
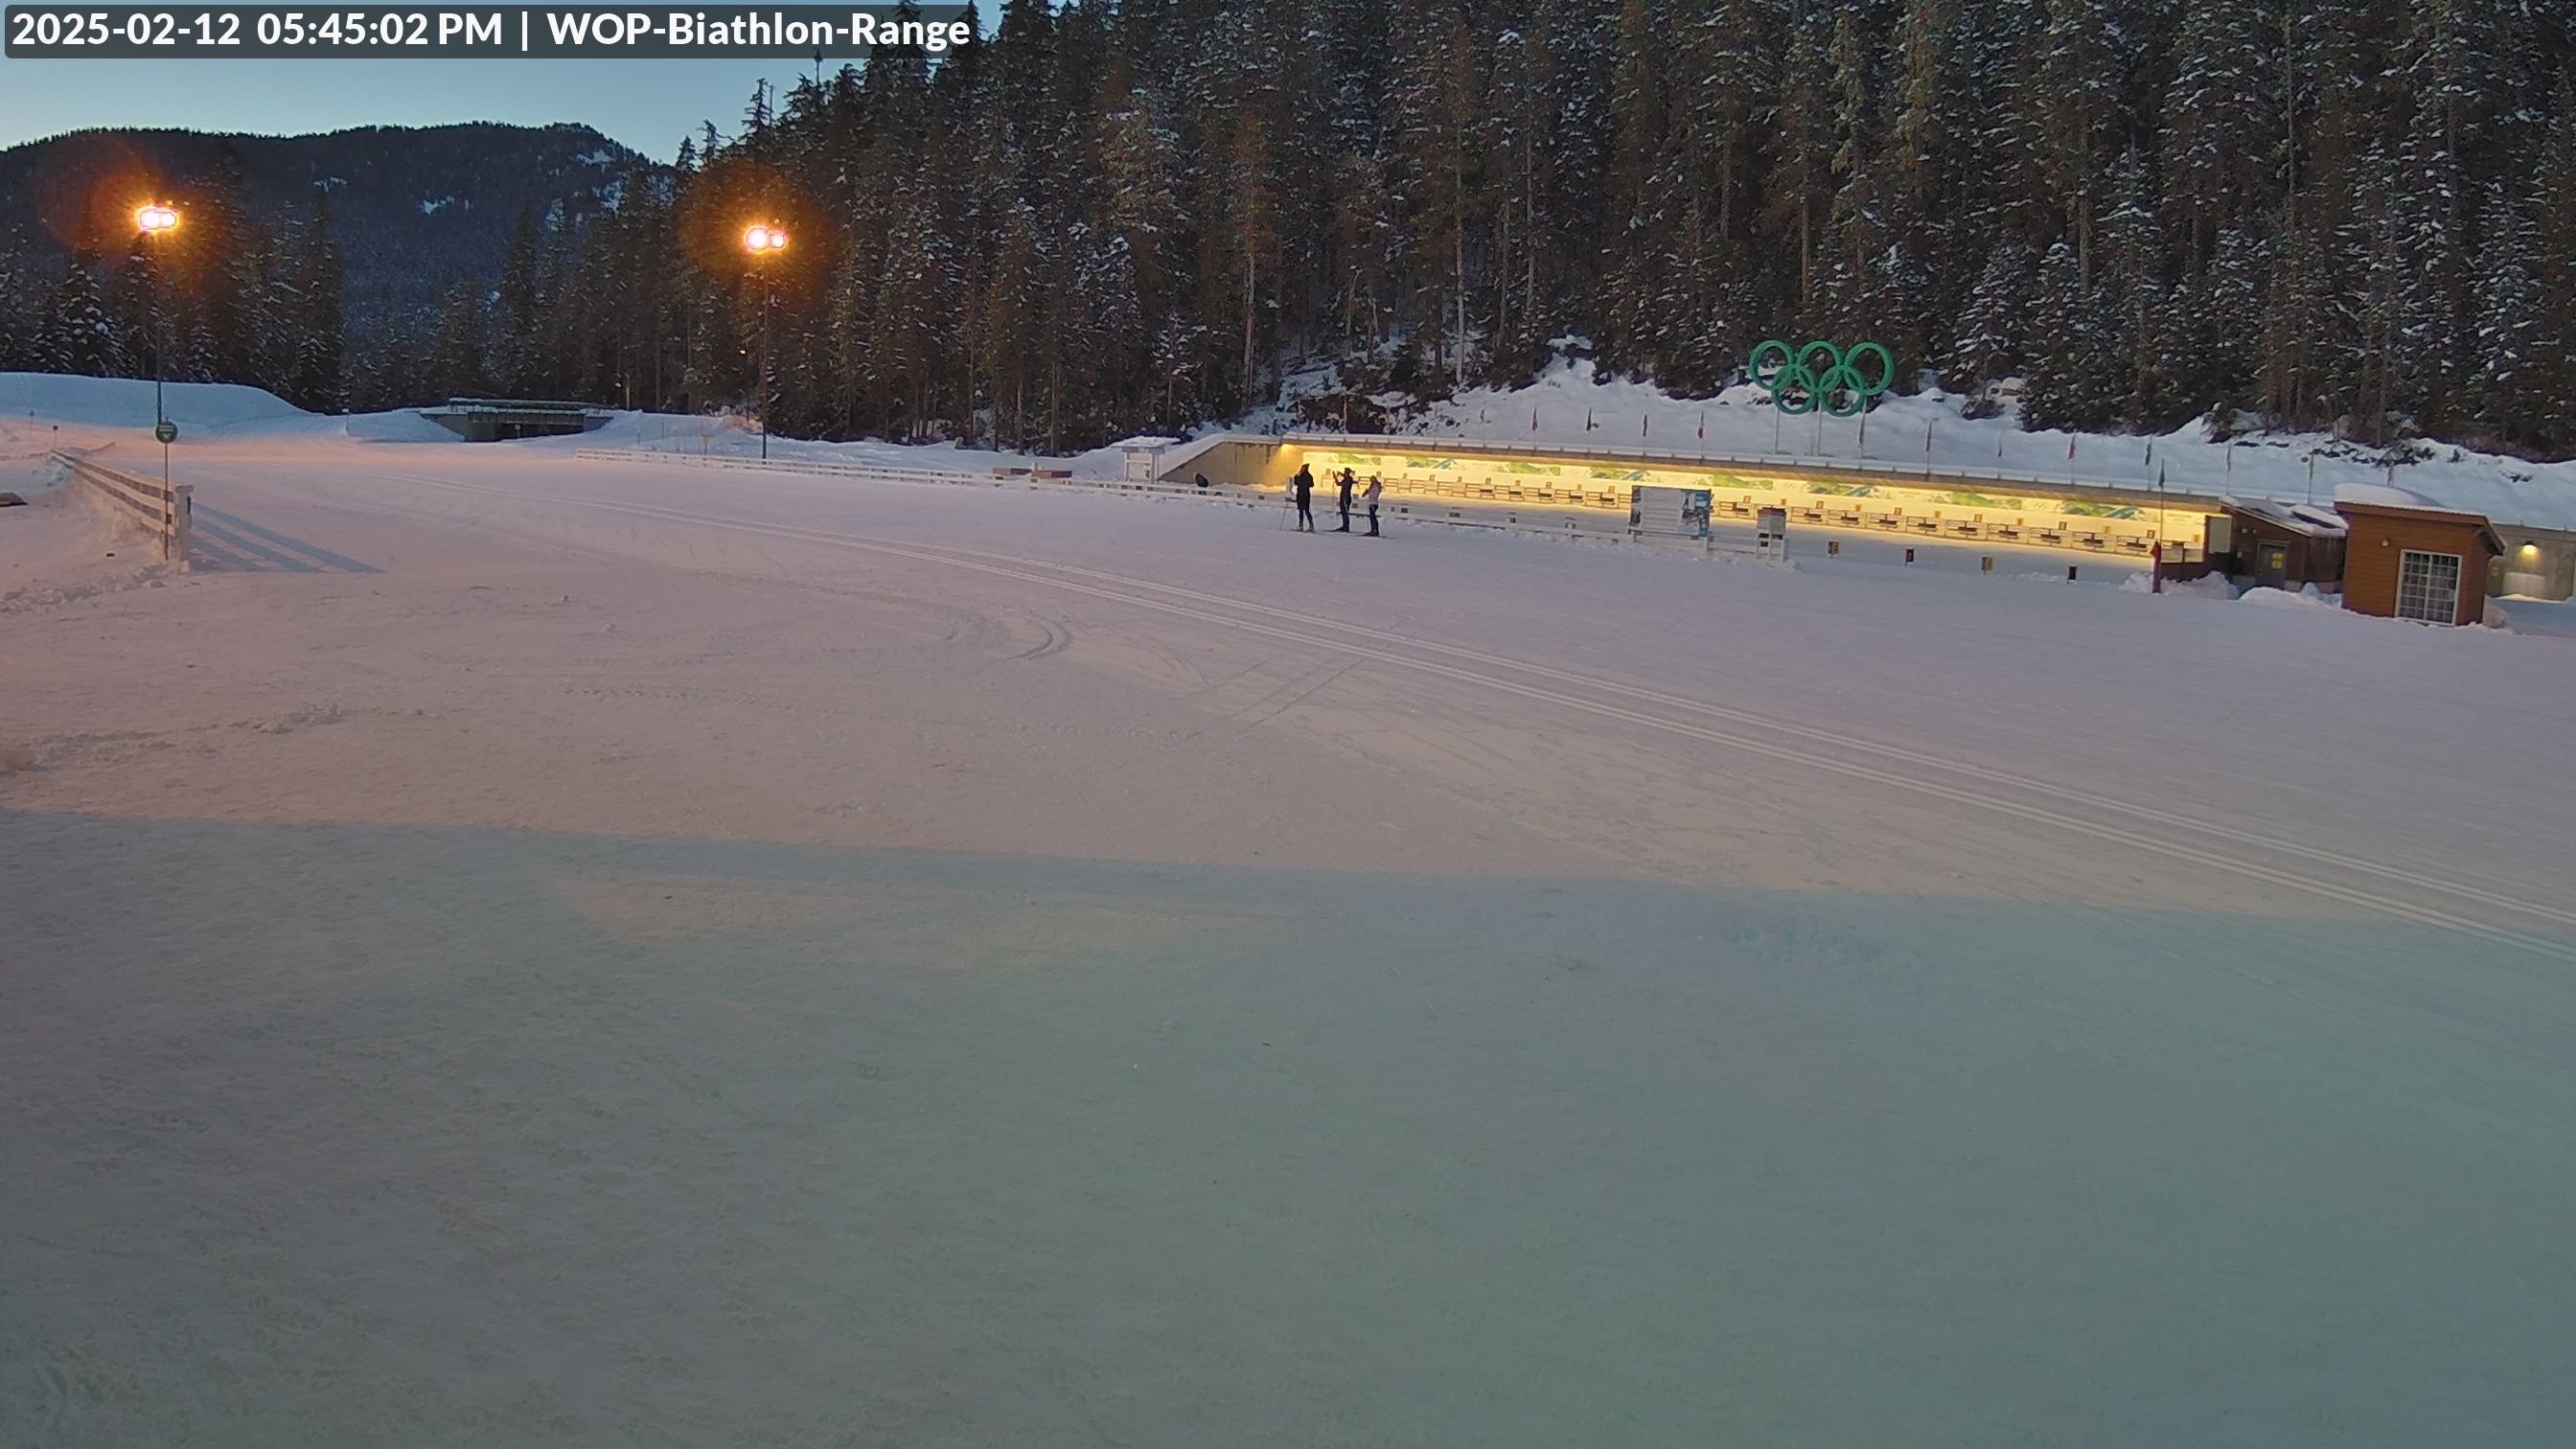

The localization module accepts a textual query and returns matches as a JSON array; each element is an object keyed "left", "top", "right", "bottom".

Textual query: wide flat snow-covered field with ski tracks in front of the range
[{"left": 0, "top": 379, "right": 2576, "bottom": 1449}]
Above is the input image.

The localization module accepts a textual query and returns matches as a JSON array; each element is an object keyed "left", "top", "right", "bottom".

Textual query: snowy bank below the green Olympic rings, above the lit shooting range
[{"left": 1277, "top": 358, "right": 2576, "bottom": 529}]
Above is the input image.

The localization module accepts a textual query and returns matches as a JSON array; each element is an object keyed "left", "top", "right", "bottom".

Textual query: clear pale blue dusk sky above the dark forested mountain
[{"left": 0, "top": 59, "right": 840, "bottom": 160}]
